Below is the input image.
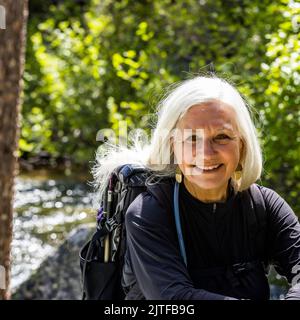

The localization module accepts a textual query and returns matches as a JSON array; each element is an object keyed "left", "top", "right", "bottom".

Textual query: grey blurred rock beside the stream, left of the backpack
[{"left": 12, "top": 227, "right": 94, "bottom": 300}]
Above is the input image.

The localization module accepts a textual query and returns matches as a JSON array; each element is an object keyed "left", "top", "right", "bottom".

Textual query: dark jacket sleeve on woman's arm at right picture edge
[{"left": 264, "top": 188, "right": 300, "bottom": 300}]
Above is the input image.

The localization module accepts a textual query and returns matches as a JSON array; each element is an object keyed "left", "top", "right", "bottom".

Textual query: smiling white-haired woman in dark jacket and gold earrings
[{"left": 95, "top": 77, "right": 300, "bottom": 300}]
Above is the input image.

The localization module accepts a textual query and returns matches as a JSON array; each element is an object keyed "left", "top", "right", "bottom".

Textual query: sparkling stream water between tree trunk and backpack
[{"left": 11, "top": 171, "right": 95, "bottom": 290}]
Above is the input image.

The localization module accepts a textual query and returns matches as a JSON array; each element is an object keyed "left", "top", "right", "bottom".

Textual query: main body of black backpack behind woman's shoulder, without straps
[{"left": 79, "top": 164, "right": 151, "bottom": 300}]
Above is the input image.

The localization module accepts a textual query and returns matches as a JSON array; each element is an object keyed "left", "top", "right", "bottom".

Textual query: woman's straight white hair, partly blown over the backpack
[{"left": 92, "top": 76, "right": 262, "bottom": 208}]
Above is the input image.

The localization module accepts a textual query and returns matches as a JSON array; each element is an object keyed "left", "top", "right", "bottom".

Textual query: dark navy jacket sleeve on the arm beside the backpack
[{"left": 125, "top": 193, "right": 237, "bottom": 300}]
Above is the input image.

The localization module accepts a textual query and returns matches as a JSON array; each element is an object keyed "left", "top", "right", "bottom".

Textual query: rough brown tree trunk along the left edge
[{"left": 0, "top": 0, "right": 28, "bottom": 300}]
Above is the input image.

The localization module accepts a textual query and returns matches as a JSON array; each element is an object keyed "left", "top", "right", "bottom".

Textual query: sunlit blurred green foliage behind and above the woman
[{"left": 20, "top": 0, "right": 300, "bottom": 209}]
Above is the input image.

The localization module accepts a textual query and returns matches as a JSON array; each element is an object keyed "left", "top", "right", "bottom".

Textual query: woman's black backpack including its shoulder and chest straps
[{"left": 79, "top": 164, "right": 267, "bottom": 300}]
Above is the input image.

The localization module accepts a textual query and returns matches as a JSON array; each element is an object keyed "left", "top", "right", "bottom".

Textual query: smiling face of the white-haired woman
[{"left": 173, "top": 100, "right": 243, "bottom": 197}]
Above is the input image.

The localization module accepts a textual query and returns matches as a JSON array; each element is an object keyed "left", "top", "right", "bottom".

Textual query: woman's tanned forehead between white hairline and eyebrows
[{"left": 177, "top": 101, "right": 237, "bottom": 130}]
